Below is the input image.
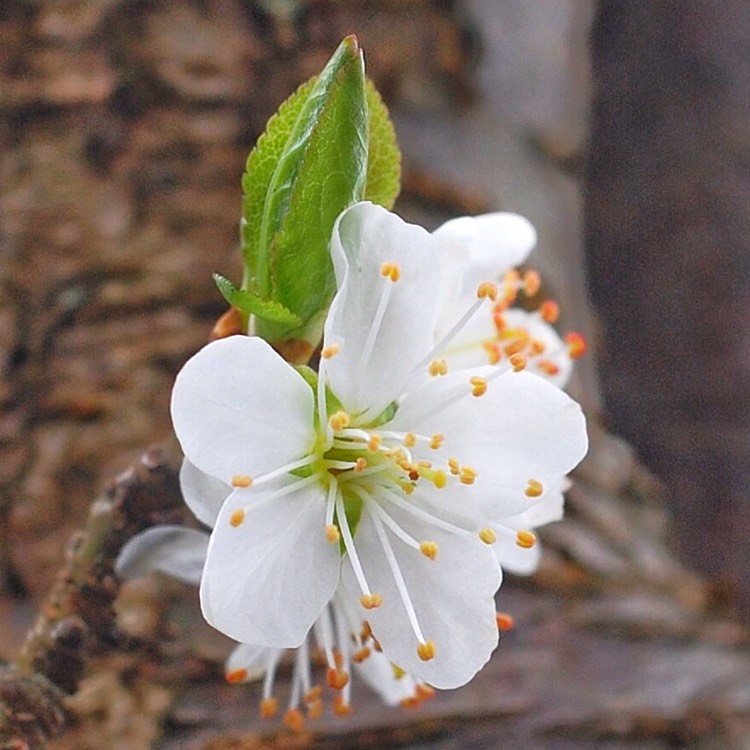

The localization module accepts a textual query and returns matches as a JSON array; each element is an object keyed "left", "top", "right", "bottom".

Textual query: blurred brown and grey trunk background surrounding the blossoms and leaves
[{"left": 0, "top": 0, "right": 750, "bottom": 750}]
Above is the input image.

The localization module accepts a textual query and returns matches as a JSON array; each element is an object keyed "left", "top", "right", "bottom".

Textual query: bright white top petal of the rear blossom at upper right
[{"left": 433, "top": 212, "right": 536, "bottom": 296}]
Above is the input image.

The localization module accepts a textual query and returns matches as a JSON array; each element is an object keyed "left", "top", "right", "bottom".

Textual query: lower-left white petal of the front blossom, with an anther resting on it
[{"left": 201, "top": 484, "right": 341, "bottom": 648}]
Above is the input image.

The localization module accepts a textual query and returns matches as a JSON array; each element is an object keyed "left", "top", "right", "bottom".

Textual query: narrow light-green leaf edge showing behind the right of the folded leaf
[{"left": 365, "top": 79, "right": 401, "bottom": 209}]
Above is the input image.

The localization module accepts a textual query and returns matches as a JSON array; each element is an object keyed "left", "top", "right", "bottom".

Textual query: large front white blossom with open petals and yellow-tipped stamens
[{"left": 172, "top": 203, "right": 586, "bottom": 688}]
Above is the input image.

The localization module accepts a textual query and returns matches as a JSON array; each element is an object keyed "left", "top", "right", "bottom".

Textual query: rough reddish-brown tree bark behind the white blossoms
[{"left": 0, "top": 0, "right": 750, "bottom": 750}]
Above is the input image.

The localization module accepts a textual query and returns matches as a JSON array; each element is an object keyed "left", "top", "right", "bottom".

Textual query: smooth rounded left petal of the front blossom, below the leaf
[{"left": 172, "top": 336, "right": 315, "bottom": 484}]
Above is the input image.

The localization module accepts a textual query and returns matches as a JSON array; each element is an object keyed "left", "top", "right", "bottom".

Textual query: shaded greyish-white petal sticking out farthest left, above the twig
[{"left": 115, "top": 526, "right": 208, "bottom": 586}]
